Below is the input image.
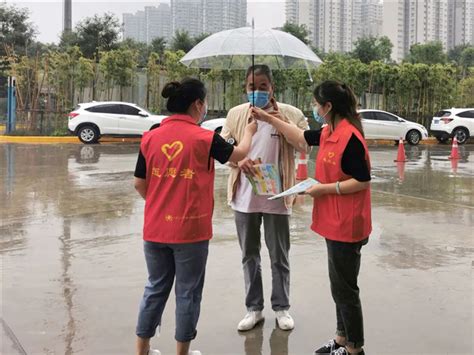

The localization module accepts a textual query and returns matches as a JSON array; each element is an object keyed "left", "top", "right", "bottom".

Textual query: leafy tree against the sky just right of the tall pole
[{"left": 75, "top": 13, "right": 120, "bottom": 61}]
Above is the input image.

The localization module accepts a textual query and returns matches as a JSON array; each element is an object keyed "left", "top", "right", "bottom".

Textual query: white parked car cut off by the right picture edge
[{"left": 430, "top": 108, "right": 474, "bottom": 144}]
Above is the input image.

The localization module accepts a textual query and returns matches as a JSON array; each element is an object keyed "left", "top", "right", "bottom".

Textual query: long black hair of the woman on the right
[{"left": 313, "top": 80, "right": 364, "bottom": 136}]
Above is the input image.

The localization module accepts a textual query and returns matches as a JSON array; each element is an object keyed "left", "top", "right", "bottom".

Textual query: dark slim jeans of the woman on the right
[{"left": 326, "top": 239, "right": 368, "bottom": 348}]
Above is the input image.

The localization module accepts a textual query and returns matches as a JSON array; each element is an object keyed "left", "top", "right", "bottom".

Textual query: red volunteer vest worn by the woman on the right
[{"left": 311, "top": 120, "right": 372, "bottom": 243}]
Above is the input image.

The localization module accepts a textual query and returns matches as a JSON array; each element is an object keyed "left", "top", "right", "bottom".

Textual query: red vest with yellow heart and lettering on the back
[{"left": 141, "top": 115, "right": 214, "bottom": 244}]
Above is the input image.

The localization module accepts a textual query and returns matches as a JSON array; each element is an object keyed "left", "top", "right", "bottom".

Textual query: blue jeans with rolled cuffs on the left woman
[{"left": 136, "top": 241, "right": 209, "bottom": 343}]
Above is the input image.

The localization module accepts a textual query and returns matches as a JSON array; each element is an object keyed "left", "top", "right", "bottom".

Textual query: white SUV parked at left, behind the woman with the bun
[{"left": 68, "top": 101, "right": 167, "bottom": 144}]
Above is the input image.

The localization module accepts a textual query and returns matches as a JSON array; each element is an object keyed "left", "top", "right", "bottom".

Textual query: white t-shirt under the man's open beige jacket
[{"left": 231, "top": 121, "right": 291, "bottom": 215}]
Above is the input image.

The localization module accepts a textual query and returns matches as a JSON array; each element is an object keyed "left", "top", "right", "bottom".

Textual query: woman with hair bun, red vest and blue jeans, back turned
[{"left": 135, "top": 79, "right": 257, "bottom": 355}]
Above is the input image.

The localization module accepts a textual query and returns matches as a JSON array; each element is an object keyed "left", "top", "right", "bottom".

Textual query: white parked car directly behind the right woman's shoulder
[{"left": 359, "top": 110, "right": 428, "bottom": 145}]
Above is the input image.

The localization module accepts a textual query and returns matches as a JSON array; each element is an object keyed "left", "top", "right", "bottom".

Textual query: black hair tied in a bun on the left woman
[{"left": 161, "top": 78, "right": 207, "bottom": 113}]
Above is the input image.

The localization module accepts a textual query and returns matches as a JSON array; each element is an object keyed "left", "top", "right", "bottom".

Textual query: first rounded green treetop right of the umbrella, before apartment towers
[{"left": 352, "top": 37, "right": 393, "bottom": 64}]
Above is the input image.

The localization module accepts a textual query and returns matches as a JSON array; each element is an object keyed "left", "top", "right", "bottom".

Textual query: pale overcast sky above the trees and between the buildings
[{"left": 7, "top": 0, "right": 285, "bottom": 42}]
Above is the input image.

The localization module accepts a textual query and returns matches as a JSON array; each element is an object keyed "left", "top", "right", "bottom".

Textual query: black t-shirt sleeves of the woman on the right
[{"left": 304, "top": 130, "right": 370, "bottom": 182}]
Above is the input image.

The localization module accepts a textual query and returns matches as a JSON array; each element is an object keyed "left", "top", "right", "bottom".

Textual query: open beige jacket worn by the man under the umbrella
[{"left": 221, "top": 102, "right": 308, "bottom": 208}]
